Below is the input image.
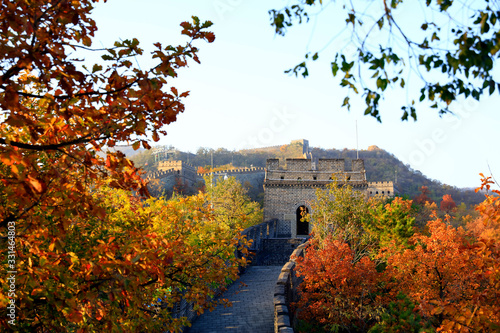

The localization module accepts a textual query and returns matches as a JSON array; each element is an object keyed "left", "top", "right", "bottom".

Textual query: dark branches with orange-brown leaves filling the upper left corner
[{"left": 0, "top": 0, "right": 214, "bottom": 232}]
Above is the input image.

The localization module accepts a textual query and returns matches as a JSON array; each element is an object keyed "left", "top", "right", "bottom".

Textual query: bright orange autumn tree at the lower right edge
[{"left": 384, "top": 214, "right": 500, "bottom": 332}]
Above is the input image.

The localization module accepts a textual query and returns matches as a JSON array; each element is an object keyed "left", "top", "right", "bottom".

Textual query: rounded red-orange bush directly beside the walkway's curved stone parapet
[{"left": 294, "top": 237, "right": 382, "bottom": 332}]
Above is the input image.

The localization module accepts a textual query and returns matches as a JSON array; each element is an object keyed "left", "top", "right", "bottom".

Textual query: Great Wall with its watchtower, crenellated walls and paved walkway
[{"left": 148, "top": 140, "right": 396, "bottom": 333}]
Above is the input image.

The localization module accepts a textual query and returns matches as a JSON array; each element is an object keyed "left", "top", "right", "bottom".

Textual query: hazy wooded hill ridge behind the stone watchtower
[{"left": 131, "top": 141, "right": 484, "bottom": 205}]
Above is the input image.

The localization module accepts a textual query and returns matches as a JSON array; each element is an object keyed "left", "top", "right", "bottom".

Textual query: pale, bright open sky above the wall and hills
[{"left": 88, "top": 0, "right": 500, "bottom": 187}]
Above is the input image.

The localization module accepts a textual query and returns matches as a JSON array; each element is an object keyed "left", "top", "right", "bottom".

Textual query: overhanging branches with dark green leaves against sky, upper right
[{"left": 269, "top": 0, "right": 500, "bottom": 121}]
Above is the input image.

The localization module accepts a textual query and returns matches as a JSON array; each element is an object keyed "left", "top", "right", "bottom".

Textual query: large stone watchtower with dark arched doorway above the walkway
[{"left": 264, "top": 159, "right": 368, "bottom": 238}]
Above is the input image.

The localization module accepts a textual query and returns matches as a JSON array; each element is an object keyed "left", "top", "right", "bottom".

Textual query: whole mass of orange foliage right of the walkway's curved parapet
[{"left": 297, "top": 176, "right": 500, "bottom": 333}]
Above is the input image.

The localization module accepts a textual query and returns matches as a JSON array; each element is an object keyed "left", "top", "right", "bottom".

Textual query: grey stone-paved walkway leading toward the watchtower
[{"left": 188, "top": 266, "right": 282, "bottom": 333}]
